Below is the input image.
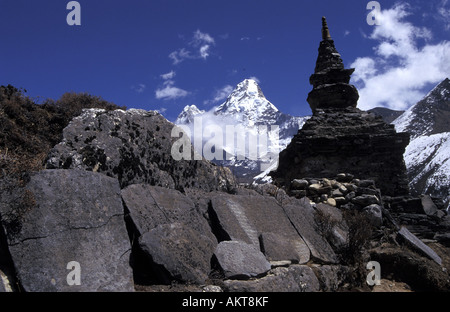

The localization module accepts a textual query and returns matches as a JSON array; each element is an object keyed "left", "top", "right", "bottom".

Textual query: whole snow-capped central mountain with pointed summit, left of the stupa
[{"left": 175, "top": 79, "right": 309, "bottom": 183}]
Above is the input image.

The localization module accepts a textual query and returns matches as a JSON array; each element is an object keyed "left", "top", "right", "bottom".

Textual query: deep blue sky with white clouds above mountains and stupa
[{"left": 0, "top": 0, "right": 450, "bottom": 121}]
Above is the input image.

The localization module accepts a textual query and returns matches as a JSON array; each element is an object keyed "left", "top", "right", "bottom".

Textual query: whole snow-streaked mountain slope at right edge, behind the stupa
[{"left": 392, "top": 78, "right": 450, "bottom": 206}]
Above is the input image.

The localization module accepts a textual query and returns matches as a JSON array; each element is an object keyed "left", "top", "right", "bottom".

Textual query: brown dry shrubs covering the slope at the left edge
[{"left": 0, "top": 85, "right": 126, "bottom": 219}]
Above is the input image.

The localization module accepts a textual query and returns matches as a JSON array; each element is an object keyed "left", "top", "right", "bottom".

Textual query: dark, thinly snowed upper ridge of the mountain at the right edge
[{"left": 393, "top": 78, "right": 450, "bottom": 139}]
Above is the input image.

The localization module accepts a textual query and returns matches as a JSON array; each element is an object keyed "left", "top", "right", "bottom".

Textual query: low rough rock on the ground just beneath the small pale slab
[{"left": 224, "top": 265, "right": 320, "bottom": 292}]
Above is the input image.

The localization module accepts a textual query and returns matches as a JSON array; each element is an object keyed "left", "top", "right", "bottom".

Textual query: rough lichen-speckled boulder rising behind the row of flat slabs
[{"left": 47, "top": 109, "right": 236, "bottom": 191}]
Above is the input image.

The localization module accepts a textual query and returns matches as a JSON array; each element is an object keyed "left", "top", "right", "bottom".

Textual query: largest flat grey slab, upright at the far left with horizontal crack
[{"left": 0, "top": 170, "right": 134, "bottom": 292}]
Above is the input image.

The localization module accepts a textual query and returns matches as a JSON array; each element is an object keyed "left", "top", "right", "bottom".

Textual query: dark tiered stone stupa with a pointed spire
[{"left": 270, "top": 17, "right": 409, "bottom": 196}]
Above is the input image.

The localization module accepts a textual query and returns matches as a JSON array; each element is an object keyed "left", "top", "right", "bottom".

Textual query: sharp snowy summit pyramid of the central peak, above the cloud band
[{"left": 215, "top": 79, "right": 278, "bottom": 122}]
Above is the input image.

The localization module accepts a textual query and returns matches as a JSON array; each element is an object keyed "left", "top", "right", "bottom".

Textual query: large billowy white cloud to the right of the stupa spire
[{"left": 350, "top": 4, "right": 450, "bottom": 109}]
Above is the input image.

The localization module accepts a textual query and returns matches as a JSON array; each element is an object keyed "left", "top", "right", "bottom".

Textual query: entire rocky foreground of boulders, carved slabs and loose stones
[{"left": 0, "top": 109, "right": 450, "bottom": 292}]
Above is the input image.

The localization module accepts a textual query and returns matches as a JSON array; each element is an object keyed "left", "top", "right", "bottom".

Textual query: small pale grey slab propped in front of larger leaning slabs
[{"left": 214, "top": 241, "right": 271, "bottom": 279}]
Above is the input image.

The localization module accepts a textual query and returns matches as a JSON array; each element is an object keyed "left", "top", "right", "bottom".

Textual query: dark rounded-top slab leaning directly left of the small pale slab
[{"left": 139, "top": 223, "right": 216, "bottom": 284}]
